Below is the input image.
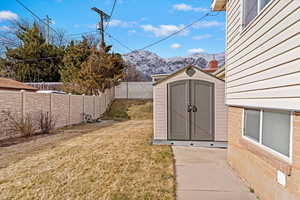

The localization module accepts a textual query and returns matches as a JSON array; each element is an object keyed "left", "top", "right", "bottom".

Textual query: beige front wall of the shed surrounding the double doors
[{"left": 153, "top": 70, "right": 227, "bottom": 141}]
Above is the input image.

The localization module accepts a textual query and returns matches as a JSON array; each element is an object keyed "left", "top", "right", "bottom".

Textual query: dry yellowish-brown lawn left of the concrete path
[{"left": 0, "top": 120, "right": 175, "bottom": 200}]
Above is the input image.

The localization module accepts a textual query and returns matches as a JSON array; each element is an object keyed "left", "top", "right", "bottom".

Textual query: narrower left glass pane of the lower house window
[{"left": 244, "top": 109, "right": 260, "bottom": 142}]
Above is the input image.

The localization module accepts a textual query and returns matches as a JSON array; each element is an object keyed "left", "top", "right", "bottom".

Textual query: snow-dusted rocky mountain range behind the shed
[{"left": 123, "top": 51, "right": 225, "bottom": 80}]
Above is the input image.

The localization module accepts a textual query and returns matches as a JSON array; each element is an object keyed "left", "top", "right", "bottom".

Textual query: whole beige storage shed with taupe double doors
[{"left": 153, "top": 66, "right": 227, "bottom": 147}]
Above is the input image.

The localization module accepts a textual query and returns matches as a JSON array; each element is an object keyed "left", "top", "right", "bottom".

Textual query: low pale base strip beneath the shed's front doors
[{"left": 153, "top": 140, "right": 227, "bottom": 148}]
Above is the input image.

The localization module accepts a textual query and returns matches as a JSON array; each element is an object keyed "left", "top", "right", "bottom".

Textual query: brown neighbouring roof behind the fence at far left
[{"left": 0, "top": 78, "right": 38, "bottom": 92}]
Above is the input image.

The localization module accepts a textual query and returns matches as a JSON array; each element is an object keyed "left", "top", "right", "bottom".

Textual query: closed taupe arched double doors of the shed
[{"left": 168, "top": 80, "right": 214, "bottom": 141}]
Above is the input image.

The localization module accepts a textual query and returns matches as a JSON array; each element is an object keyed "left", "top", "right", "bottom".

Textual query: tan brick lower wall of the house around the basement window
[{"left": 228, "top": 107, "right": 300, "bottom": 200}]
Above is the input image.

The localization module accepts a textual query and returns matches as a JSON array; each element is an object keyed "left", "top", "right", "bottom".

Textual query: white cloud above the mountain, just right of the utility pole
[{"left": 141, "top": 24, "right": 189, "bottom": 37}]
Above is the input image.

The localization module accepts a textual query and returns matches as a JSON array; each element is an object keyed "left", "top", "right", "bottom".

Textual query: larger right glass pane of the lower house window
[{"left": 262, "top": 111, "right": 290, "bottom": 157}]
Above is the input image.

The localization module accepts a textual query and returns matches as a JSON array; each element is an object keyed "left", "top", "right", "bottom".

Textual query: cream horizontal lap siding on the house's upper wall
[{"left": 226, "top": 0, "right": 300, "bottom": 110}]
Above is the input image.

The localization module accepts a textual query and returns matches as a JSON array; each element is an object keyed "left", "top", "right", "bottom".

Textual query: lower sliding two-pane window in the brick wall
[{"left": 243, "top": 109, "right": 292, "bottom": 159}]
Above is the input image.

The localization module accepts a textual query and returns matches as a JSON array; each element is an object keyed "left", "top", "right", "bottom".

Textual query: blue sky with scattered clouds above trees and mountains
[{"left": 0, "top": 0, "right": 225, "bottom": 57}]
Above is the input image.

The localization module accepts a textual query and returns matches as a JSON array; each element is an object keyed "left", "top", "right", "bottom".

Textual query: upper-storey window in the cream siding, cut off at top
[{"left": 243, "top": 0, "right": 271, "bottom": 27}]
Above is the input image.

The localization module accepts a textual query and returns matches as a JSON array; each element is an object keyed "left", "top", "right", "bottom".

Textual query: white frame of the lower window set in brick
[{"left": 242, "top": 108, "right": 294, "bottom": 164}]
